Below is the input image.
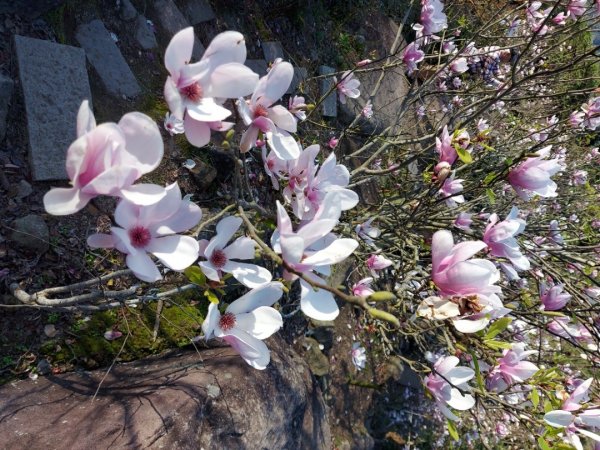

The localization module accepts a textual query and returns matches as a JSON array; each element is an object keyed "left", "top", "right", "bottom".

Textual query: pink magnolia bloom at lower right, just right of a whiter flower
[{"left": 487, "top": 343, "right": 539, "bottom": 392}]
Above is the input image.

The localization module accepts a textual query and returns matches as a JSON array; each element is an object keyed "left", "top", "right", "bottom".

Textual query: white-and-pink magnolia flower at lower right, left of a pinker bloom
[{"left": 425, "top": 356, "right": 475, "bottom": 420}]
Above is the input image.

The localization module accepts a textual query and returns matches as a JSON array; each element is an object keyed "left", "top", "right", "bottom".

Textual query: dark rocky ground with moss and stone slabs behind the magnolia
[{"left": 0, "top": 0, "right": 434, "bottom": 449}]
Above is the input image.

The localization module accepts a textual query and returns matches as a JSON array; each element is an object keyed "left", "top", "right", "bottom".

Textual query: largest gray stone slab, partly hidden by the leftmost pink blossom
[{"left": 15, "top": 36, "right": 92, "bottom": 181}]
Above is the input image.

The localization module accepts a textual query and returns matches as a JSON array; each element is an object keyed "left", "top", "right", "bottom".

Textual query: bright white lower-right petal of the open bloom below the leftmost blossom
[{"left": 146, "top": 234, "right": 199, "bottom": 271}]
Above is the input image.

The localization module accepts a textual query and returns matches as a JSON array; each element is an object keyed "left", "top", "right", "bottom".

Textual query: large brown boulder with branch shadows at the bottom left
[{"left": 0, "top": 338, "right": 331, "bottom": 450}]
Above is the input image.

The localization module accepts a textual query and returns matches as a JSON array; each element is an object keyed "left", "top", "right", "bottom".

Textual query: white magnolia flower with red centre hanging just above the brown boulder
[{"left": 202, "top": 281, "right": 283, "bottom": 370}]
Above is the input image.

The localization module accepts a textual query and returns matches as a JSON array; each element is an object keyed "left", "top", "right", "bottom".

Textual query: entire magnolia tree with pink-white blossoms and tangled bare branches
[{"left": 7, "top": 0, "right": 600, "bottom": 449}]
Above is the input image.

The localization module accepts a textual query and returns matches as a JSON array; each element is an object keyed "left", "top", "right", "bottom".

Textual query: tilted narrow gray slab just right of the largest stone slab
[{"left": 75, "top": 20, "right": 142, "bottom": 97}]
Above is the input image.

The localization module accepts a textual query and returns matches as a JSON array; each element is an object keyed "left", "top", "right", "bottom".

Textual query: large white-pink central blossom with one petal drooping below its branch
[{"left": 271, "top": 199, "right": 358, "bottom": 320}]
